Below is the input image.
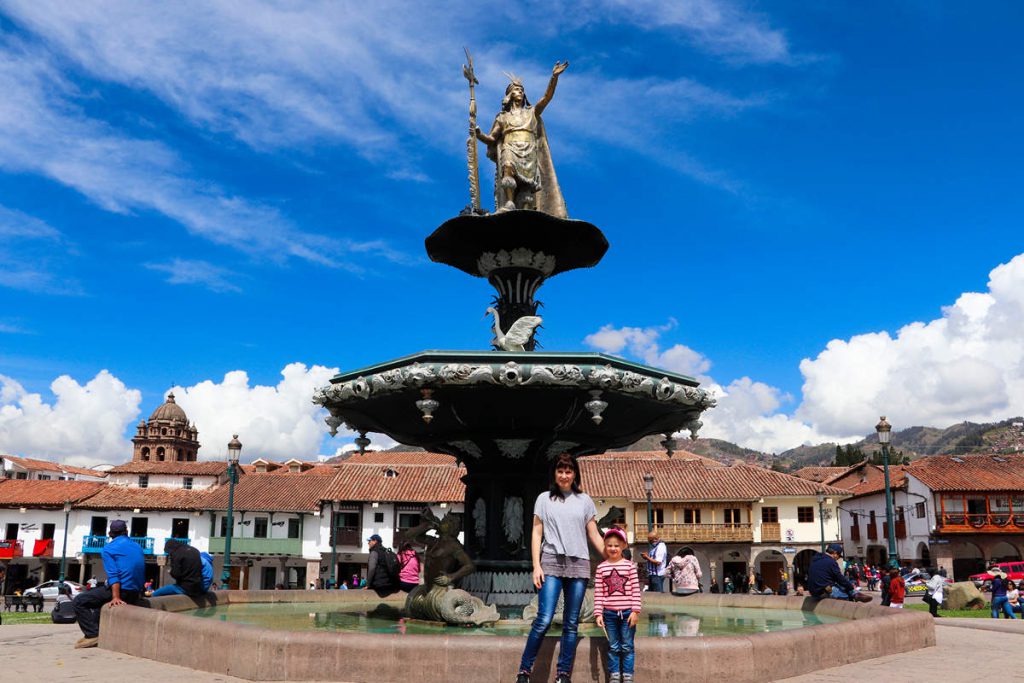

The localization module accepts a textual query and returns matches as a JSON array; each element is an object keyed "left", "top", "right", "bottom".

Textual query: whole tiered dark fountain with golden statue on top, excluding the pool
[{"left": 313, "top": 52, "right": 715, "bottom": 606}]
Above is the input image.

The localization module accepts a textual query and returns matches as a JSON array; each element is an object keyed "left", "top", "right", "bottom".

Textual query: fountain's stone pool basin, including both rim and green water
[{"left": 99, "top": 591, "right": 935, "bottom": 683}]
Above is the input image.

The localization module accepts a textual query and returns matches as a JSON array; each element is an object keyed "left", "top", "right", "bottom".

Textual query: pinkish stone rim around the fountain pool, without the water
[{"left": 99, "top": 591, "right": 935, "bottom": 683}]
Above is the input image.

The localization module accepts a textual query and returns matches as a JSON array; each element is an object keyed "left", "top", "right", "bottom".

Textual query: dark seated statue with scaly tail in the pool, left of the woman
[{"left": 406, "top": 508, "right": 499, "bottom": 626}]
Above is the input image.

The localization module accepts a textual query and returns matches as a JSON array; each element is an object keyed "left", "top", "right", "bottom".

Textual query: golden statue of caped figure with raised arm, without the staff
[{"left": 477, "top": 61, "right": 569, "bottom": 218}]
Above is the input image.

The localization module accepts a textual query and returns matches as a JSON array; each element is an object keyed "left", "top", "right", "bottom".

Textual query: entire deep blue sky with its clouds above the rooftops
[{"left": 0, "top": 0, "right": 1024, "bottom": 462}]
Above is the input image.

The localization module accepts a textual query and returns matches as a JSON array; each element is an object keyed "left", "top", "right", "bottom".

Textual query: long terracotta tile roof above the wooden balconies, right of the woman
[{"left": 580, "top": 457, "right": 848, "bottom": 501}]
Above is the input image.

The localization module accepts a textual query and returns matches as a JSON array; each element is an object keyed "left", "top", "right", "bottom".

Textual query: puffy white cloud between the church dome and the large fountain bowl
[{"left": 174, "top": 362, "right": 338, "bottom": 461}]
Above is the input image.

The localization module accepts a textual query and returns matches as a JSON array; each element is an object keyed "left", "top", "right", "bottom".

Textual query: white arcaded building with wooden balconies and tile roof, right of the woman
[{"left": 580, "top": 453, "right": 849, "bottom": 589}]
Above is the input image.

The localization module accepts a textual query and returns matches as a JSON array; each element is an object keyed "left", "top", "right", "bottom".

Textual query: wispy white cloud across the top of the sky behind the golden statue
[{"left": 6, "top": 0, "right": 774, "bottom": 189}]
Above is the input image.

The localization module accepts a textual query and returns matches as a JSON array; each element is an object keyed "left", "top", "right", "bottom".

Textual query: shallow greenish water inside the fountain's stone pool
[{"left": 181, "top": 602, "right": 842, "bottom": 637}]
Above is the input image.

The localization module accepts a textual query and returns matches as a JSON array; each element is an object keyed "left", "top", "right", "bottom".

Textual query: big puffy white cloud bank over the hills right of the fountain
[{"left": 584, "top": 254, "right": 1024, "bottom": 453}]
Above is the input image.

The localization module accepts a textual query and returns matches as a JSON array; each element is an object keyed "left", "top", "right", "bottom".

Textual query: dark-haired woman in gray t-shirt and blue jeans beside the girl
[{"left": 516, "top": 454, "right": 604, "bottom": 683}]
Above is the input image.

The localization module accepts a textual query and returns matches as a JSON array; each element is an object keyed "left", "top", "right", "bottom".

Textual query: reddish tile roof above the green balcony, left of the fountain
[{"left": 206, "top": 472, "right": 335, "bottom": 512}]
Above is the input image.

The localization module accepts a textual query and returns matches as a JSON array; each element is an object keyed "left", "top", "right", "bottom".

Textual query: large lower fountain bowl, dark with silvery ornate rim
[{"left": 313, "top": 351, "right": 715, "bottom": 458}]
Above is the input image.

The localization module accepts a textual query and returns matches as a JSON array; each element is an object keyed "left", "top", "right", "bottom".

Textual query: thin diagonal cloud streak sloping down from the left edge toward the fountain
[{"left": 0, "top": 33, "right": 400, "bottom": 270}]
